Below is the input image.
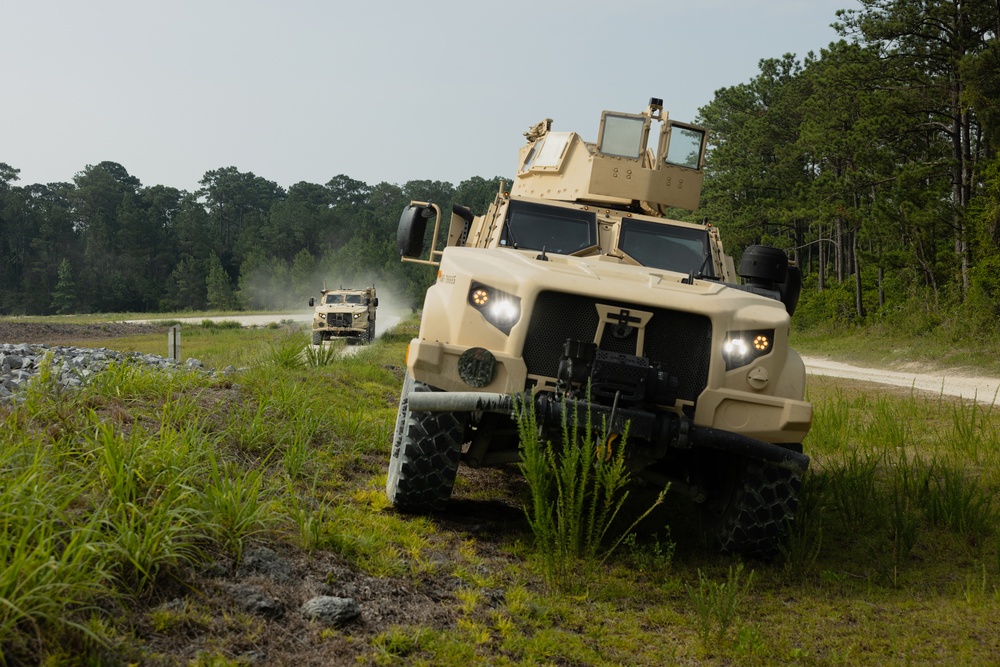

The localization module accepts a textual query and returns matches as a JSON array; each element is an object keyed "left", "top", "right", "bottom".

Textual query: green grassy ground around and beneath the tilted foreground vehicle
[{"left": 0, "top": 320, "right": 1000, "bottom": 666}]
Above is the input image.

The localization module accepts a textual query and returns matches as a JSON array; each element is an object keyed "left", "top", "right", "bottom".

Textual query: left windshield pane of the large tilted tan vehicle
[{"left": 500, "top": 201, "right": 597, "bottom": 255}]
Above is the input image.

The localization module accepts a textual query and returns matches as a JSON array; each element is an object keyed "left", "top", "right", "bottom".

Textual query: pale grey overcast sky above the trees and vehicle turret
[{"left": 0, "top": 0, "right": 858, "bottom": 191}]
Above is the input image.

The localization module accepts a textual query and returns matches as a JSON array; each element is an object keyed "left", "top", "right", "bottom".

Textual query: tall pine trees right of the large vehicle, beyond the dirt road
[{"left": 698, "top": 0, "right": 1000, "bottom": 332}]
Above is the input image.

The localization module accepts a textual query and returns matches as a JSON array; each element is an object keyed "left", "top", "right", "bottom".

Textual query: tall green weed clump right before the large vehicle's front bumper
[{"left": 517, "top": 394, "right": 666, "bottom": 591}]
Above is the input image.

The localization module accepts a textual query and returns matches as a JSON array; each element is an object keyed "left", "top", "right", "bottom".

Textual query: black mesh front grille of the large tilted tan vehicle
[{"left": 524, "top": 292, "right": 712, "bottom": 401}]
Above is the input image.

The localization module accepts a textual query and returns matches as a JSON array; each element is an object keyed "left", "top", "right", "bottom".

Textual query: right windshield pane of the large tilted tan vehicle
[{"left": 618, "top": 219, "right": 715, "bottom": 278}]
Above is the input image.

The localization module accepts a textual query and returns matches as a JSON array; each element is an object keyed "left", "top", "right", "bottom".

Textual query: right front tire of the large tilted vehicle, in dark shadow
[{"left": 704, "top": 460, "right": 802, "bottom": 559}]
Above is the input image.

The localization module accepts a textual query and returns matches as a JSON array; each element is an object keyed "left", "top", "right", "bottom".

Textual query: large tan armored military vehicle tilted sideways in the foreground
[{"left": 386, "top": 99, "right": 812, "bottom": 556}]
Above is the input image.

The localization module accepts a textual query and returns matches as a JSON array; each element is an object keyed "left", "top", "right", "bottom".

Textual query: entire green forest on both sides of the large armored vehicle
[{"left": 0, "top": 0, "right": 1000, "bottom": 335}]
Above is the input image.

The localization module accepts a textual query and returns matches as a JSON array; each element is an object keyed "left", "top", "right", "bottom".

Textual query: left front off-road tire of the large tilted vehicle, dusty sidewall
[{"left": 385, "top": 374, "right": 468, "bottom": 513}]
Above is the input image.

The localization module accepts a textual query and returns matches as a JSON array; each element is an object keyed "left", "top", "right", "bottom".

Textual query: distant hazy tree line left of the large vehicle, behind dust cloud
[{"left": 0, "top": 162, "right": 501, "bottom": 315}]
